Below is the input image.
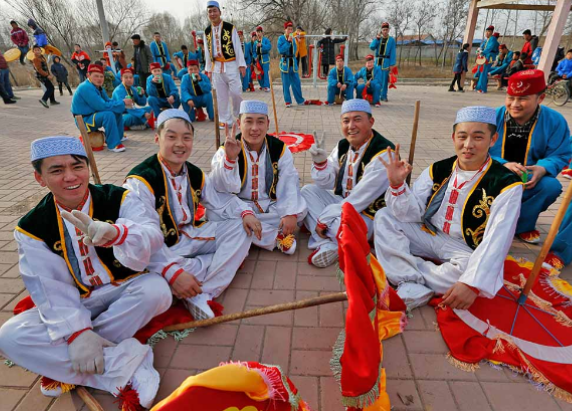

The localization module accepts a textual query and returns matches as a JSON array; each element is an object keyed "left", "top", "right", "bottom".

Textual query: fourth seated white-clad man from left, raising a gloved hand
[{"left": 302, "top": 99, "right": 395, "bottom": 267}]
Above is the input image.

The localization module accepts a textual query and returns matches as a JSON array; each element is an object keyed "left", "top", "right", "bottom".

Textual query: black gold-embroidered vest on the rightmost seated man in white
[{"left": 427, "top": 156, "right": 522, "bottom": 250}]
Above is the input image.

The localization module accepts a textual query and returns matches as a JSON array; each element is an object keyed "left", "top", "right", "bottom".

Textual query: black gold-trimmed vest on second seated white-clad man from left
[{"left": 126, "top": 154, "right": 205, "bottom": 247}]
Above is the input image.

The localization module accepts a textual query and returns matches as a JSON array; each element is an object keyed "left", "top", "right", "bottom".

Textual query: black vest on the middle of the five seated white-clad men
[{"left": 230, "top": 133, "right": 286, "bottom": 201}]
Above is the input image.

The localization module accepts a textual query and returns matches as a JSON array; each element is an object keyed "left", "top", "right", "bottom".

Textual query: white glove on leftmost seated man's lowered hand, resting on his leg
[{"left": 68, "top": 330, "right": 115, "bottom": 374}]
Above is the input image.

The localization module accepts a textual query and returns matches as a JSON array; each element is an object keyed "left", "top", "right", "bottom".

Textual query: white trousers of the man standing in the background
[{"left": 213, "top": 67, "right": 242, "bottom": 124}]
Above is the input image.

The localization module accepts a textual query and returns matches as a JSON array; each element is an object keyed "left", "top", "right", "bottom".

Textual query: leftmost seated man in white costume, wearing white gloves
[{"left": 0, "top": 137, "right": 172, "bottom": 408}]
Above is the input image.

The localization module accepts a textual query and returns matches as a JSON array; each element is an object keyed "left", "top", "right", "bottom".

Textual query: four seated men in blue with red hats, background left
[{"left": 71, "top": 60, "right": 214, "bottom": 153}]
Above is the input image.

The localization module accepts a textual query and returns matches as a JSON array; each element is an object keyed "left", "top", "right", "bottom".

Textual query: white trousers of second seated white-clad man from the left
[{"left": 171, "top": 219, "right": 252, "bottom": 298}]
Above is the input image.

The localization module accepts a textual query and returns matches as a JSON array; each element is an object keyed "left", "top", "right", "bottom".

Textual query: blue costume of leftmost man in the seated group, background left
[{"left": 71, "top": 80, "right": 125, "bottom": 149}]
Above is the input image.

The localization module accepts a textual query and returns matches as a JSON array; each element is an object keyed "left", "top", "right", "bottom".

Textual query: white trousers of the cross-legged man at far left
[{"left": 0, "top": 274, "right": 172, "bottom": 393}]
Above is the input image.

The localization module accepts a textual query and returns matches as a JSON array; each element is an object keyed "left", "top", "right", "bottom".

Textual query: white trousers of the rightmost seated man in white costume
[{"left": 374, "top": 208, "right": 473, "bottom": 294}]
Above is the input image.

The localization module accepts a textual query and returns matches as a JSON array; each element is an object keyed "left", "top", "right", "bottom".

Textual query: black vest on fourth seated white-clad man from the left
[{"left": 334, "top": 130, "right": 395, "bottom": 220}]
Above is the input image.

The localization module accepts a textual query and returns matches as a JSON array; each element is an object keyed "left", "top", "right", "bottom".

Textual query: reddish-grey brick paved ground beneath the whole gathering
[{"left": 0, "top": 86, "right": 572, "bottom": 411}]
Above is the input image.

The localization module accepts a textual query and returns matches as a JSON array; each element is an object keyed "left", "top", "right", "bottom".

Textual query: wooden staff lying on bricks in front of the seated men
[{"left": 163, "top": 292, "right": 346, "bottom": 332}]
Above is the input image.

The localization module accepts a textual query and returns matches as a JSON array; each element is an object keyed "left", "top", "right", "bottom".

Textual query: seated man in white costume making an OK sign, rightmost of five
[{"left": 375, "top": 106, "right": 523, "bottom": 309}]
